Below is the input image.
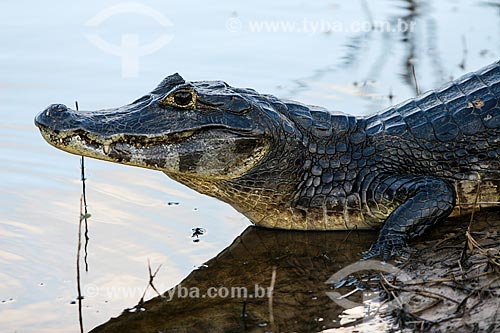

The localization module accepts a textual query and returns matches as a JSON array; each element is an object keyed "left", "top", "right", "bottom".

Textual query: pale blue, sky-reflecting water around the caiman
[{"left": 0, "top": 0, "right": 500, "bottom": 332}]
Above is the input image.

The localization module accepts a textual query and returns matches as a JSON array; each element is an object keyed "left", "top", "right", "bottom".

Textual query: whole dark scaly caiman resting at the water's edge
[{"left": 35, "top": 63, "right": 500, "bottom": 259}]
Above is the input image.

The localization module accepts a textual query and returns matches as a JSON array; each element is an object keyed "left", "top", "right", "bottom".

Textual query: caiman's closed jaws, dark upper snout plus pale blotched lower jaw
[{"left": 35, "top": 102, "right": 269, "bottom": 179}]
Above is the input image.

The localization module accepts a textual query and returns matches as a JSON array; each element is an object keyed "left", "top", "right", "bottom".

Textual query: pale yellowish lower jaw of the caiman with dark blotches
[{"left": 40, "top": 127, "right": 270, "bottom": 180}]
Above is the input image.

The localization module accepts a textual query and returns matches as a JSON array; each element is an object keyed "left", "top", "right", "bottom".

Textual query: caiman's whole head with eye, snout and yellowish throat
[{"left": 35, "top": 74, "right": 303, "bottom": 226}]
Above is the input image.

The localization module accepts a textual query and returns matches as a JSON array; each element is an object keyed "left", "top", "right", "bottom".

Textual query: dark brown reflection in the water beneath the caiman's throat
[{"left": 92, "top": 227, "right": 376, "bottom": 333}]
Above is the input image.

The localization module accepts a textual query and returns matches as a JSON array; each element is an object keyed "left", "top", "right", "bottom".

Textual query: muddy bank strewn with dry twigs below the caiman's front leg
[{"left": 380, "top": 210, "right": 500, "bottom": 332}]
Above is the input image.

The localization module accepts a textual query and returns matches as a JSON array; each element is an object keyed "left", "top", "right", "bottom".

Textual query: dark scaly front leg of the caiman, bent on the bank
[{"left": 363, "top": 176, "right": 455, "bottom": 261}]
